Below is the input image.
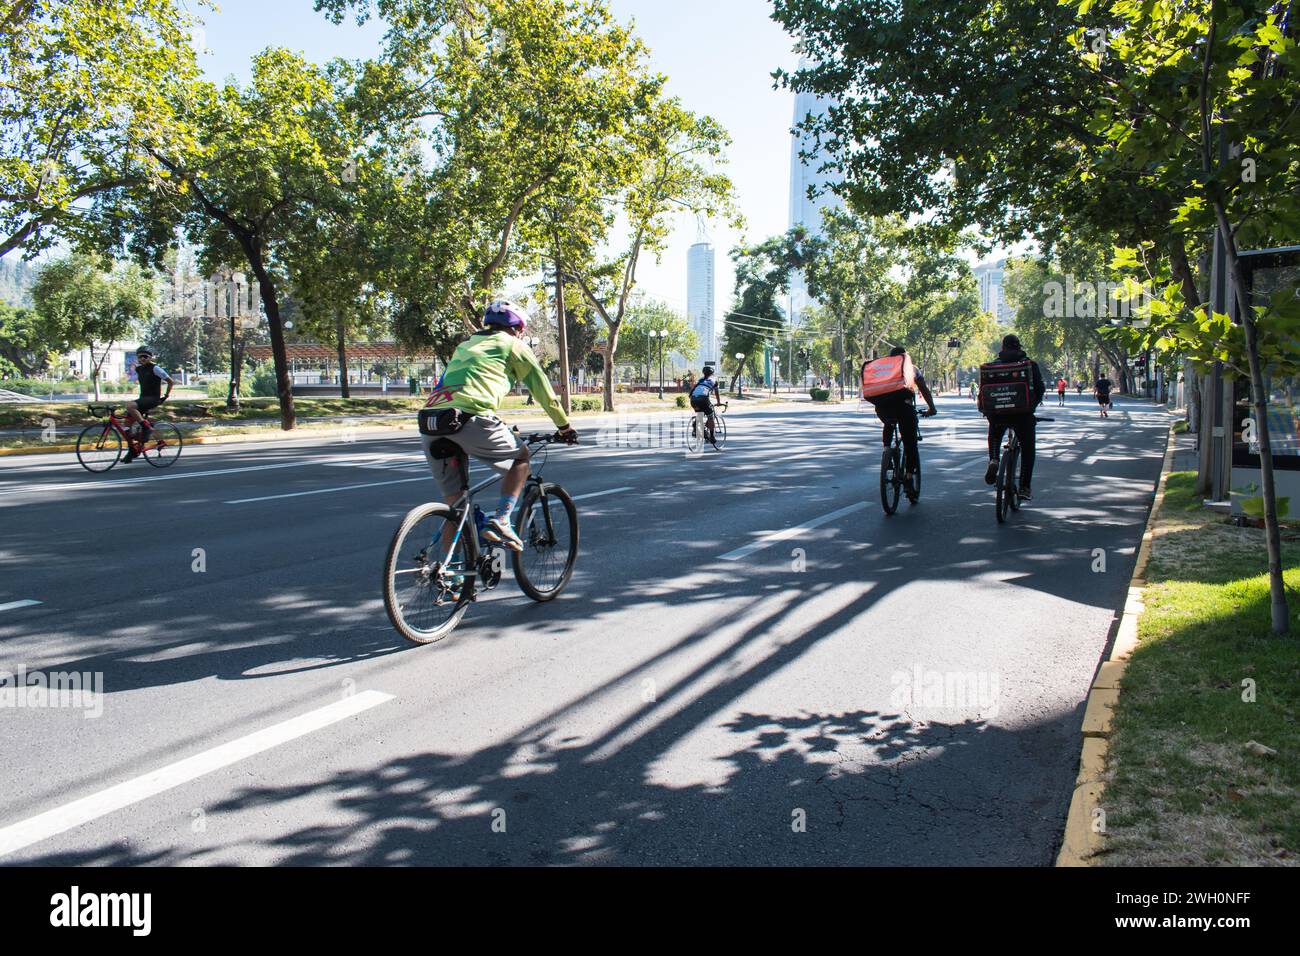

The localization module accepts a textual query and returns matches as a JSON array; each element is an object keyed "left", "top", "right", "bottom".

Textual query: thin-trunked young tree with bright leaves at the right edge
[{"left": 1076, "top": 0, "right": 1300, "bottom": 633}]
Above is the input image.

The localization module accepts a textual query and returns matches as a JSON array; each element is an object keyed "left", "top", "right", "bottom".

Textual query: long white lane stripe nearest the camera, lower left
[{"left": 0, "top": 691, "right": 394, "bottom": 857}]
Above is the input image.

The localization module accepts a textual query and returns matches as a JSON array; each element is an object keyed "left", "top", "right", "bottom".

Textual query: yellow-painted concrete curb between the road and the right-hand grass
[{"left": 1056, "top": 423, "right": 1178, "bottom": 866}]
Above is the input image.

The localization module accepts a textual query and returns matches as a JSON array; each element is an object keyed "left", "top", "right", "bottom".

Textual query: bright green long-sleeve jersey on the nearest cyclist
[{"left": 428, "top": 329, "right": 568, "bottom": 427}]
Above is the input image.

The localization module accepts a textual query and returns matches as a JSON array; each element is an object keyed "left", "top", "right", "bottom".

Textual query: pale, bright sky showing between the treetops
[{"left": 189, "top": 0, "right": 796, "bottom": 312}]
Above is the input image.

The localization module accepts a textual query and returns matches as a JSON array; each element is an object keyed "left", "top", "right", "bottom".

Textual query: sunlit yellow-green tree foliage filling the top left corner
[{"left": 0, "top": 0, "right": 198, "bottom": 258}]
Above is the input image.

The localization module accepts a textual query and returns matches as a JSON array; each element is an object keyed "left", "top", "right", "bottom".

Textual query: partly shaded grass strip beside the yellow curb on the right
[{"left": 1104, "top": 472, "right": 1300, "bottom": 866}]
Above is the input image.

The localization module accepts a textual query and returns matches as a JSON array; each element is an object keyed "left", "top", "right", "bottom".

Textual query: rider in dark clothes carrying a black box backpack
[{"left": 979, "top": 336, "right": 1047, "bottom": 501}]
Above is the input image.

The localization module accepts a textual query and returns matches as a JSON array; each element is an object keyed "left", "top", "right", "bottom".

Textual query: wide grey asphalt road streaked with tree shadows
[{"left": 0, "top": 395, "right": 1167, "bottom": 865}]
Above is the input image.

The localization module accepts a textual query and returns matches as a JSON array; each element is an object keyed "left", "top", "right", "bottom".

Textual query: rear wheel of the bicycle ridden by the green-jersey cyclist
[{"left": 384, "top": 502, "right": 478, "bottom": 644}]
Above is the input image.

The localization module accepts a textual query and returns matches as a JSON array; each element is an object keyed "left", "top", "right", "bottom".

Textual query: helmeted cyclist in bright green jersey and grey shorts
[{"left": 421, "top": 300, "right": 577, "bottom": 551}]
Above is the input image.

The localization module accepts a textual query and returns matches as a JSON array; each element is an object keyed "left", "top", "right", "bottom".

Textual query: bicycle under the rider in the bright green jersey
[{"left": 384, "top": 429, "right": 577, "bottom": 644}]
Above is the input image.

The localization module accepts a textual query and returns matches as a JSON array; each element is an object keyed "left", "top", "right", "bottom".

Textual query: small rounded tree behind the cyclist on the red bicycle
[{"left": 31, "top": 254, "right": 157, "bottom": 399}]
